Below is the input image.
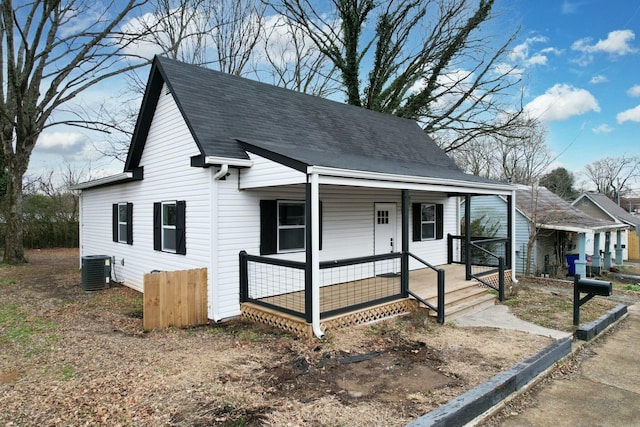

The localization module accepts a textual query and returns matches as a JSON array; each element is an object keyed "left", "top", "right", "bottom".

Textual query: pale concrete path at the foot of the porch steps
[{"left": 453, "top": 305, "right": 571, "bottom": 339}]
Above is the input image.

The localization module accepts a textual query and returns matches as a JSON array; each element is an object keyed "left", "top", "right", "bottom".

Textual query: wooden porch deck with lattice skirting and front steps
[{"left": 242, "top": 264, "right": 495, "bottom": 335}]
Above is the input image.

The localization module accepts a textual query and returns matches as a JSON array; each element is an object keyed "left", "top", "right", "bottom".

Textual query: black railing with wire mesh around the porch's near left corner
[{"left": 240, "top": 251, "right": 403, "bottom": 322}]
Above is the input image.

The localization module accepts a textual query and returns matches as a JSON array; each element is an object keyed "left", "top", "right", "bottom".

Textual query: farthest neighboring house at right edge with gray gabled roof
[{"left": 572, "top": 193, "right": 640, "bottom": 264}]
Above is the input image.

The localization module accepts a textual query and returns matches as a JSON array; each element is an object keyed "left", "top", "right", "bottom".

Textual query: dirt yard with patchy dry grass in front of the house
[{"left": 0, "top": 250, "right": 620, "bottom": 426}]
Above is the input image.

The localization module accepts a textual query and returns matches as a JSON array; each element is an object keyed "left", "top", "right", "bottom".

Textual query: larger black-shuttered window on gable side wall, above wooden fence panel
[{"left": 153, "top": 201, "right": 187, "bottom": 255}]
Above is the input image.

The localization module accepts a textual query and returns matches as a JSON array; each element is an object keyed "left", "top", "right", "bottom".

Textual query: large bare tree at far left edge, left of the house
[{"left": 0, "top": 0, "right": 144, "bottom": 264}]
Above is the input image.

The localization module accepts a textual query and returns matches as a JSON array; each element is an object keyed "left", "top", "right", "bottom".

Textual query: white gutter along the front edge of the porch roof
[{"left": 307, "top": 166, "right": 513, "bottom": 195}]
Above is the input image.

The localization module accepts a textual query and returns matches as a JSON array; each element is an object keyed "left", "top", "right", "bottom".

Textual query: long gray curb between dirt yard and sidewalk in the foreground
[{"left": 406, "top": 337, "right": 572, "bottom": 427}]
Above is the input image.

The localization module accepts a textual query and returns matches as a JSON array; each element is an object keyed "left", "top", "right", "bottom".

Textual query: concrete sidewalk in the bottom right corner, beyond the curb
[{"left": 501, "top": 304, "right": 640, "bottom": 427}]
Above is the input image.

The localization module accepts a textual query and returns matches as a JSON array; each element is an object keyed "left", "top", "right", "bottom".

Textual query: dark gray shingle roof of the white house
[{"left": 125, "top": 58, "right": 504, "bottom": 183}]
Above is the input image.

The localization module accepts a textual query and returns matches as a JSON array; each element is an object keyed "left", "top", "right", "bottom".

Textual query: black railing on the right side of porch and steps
[{"left": 448, "top": 235, "right": 510, "bottom": 301}]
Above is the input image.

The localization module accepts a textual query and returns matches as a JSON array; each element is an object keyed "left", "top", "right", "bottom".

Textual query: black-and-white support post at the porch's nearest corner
[{"left": 305, "top": 173, "right": 324, "bottom": 338}]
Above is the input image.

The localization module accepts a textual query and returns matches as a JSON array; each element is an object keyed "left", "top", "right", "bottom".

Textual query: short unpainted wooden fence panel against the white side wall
[{"left": 143, "top": 268, "right": 209, "bottom": 331}]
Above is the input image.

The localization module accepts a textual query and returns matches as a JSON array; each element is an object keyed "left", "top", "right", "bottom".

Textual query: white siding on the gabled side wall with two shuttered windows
[{"left": 81, "top": 85, "right": 213, "bottom": 298}]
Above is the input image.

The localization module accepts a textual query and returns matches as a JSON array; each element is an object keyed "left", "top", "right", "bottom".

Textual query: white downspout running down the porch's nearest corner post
[{"left": 311, "top": 173, "right": 324, "bottom": 338}]
